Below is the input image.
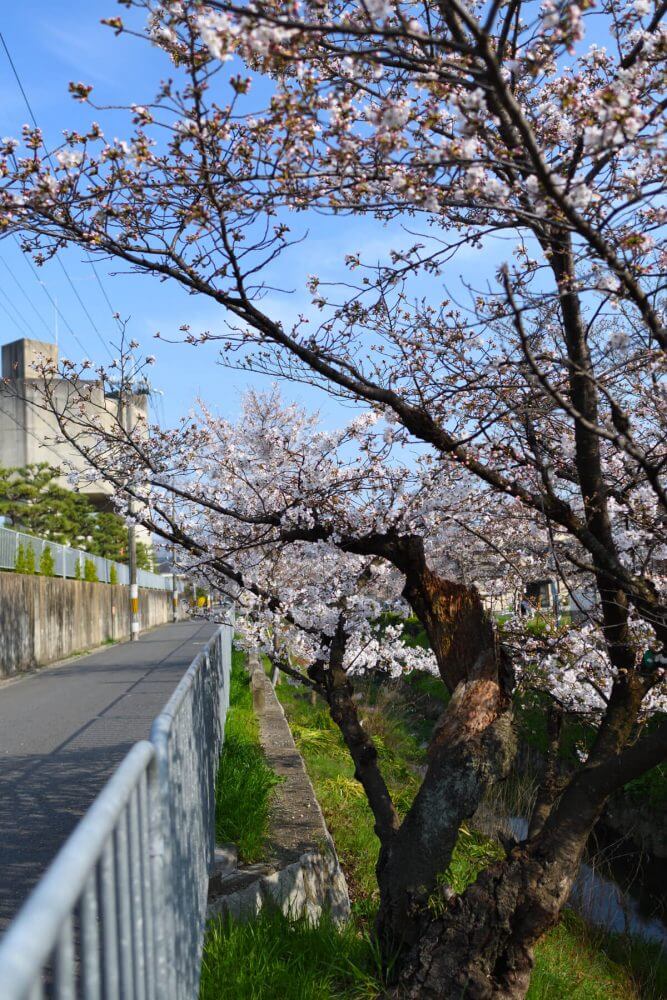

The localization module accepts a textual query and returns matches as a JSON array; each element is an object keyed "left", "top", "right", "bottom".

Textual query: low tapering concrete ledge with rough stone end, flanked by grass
[{"left": 208, "top": 655, "right": 350, "bottom": 923}]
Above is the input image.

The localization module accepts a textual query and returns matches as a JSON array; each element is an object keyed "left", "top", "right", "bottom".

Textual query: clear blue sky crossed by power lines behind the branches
[{"left": 0, "top": 0, "right": 506, "bottom": 424}]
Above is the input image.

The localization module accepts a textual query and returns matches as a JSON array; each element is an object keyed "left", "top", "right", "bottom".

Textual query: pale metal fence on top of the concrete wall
[{"left": 0, "top": 527, "right": 172, "bottom": 590}]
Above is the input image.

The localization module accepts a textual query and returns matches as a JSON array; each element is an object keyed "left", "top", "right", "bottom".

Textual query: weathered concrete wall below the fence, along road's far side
[{"left": 0, "top": 573, "right": 171, "bottom": 677}]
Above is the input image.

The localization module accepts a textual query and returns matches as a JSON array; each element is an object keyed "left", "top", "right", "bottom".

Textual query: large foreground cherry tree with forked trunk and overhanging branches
[{"left": 0, "top": 0, "right": 667, "bottom": 997}]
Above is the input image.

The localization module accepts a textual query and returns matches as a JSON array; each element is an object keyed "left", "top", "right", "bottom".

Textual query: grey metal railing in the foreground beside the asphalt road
[{"left": 0, "top": 620, "right": 233, "bottom": 1000}]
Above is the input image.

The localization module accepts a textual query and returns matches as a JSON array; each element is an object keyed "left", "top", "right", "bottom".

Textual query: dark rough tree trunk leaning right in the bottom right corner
[{"left": 388, "top": 674, "right": 667, "bottom": 1000}]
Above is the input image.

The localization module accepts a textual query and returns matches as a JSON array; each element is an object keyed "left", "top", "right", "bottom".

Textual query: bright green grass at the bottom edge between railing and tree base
[{"left": 199, "top": 910, "right": 379, "bottom": 1000}]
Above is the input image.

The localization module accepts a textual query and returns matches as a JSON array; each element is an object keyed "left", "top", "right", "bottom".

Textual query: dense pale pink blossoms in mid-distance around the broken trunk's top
[{"left": 34, "top": 342, "right": 667, "bottom": 717}]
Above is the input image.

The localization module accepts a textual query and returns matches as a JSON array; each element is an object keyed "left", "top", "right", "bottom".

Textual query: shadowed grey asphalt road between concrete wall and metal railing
[{"left": 0, "top": 621, "right": 216, "bottom": 932}]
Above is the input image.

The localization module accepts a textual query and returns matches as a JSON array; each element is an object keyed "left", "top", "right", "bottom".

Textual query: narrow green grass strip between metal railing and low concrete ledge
[{"left": 215, "top": 650, "right": 279, "bottom": 863}]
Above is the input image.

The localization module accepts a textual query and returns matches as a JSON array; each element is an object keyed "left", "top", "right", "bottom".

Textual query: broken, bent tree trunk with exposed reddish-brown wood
[{"left": 377, "top": 539, "right": 516, "bottom": 961}]
